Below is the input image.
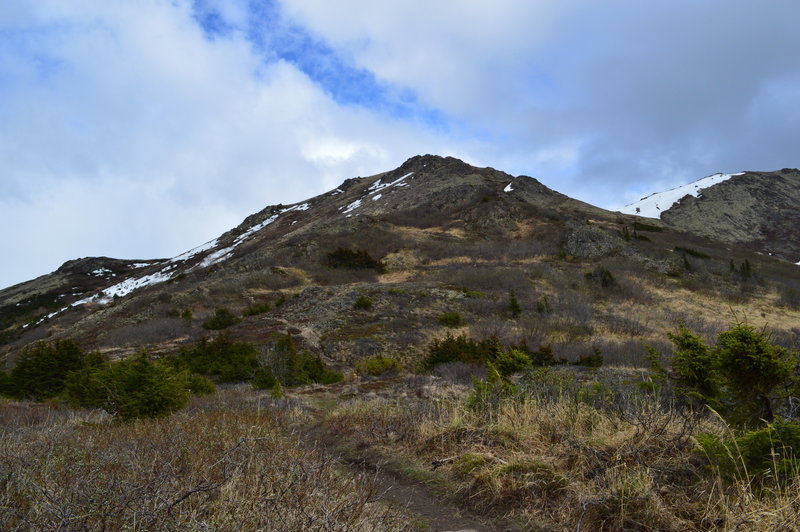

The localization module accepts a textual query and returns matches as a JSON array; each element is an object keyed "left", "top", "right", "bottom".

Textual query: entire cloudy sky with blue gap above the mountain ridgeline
[{"left": 0, "top": 0, "right": 800, "bottom": 287}]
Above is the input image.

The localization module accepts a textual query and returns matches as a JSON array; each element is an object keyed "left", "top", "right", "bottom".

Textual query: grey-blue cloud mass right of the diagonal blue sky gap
[{"left": 285, "top": 0, "right": 800, "bottom": 205}]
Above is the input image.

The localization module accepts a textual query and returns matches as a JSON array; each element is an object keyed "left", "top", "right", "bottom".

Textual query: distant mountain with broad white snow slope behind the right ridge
[{"left": 622, "top": 168, "right": 800, "bottom": 262}]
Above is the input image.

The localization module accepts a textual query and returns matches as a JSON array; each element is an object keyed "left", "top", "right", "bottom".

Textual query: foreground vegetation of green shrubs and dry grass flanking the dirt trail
[{"left": 0, "top": 323, "right": 800, "bottom": 530}]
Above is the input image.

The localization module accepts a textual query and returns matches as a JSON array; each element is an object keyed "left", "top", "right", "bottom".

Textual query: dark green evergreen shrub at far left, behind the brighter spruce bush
[{"left": 6, "top": 339, "right": 85, "bottom": 400}]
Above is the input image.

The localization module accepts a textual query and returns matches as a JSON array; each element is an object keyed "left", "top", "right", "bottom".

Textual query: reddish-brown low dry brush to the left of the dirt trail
[{"left": 0, "top": 388, "right": 407, "bottom": 531}]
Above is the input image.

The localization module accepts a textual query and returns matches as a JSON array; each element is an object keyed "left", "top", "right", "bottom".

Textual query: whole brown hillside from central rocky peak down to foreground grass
[{"left": 0, "top": 156, "right": 800, "bottom": 532}]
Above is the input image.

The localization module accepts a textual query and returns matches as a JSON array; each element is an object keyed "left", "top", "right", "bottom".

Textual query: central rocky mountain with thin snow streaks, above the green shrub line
[{"left": 0, "top": 155, "right": 800, "bottom": 367}]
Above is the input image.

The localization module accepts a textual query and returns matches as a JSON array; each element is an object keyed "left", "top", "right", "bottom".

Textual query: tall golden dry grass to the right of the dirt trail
[{"left": 328, "top": 376, "right": 800, "bottom": 531}]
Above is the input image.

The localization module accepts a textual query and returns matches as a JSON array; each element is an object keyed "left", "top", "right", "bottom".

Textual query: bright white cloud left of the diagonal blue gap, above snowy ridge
[{"left": 0, "top": 0, "right": 462, "bottom": 285}]
